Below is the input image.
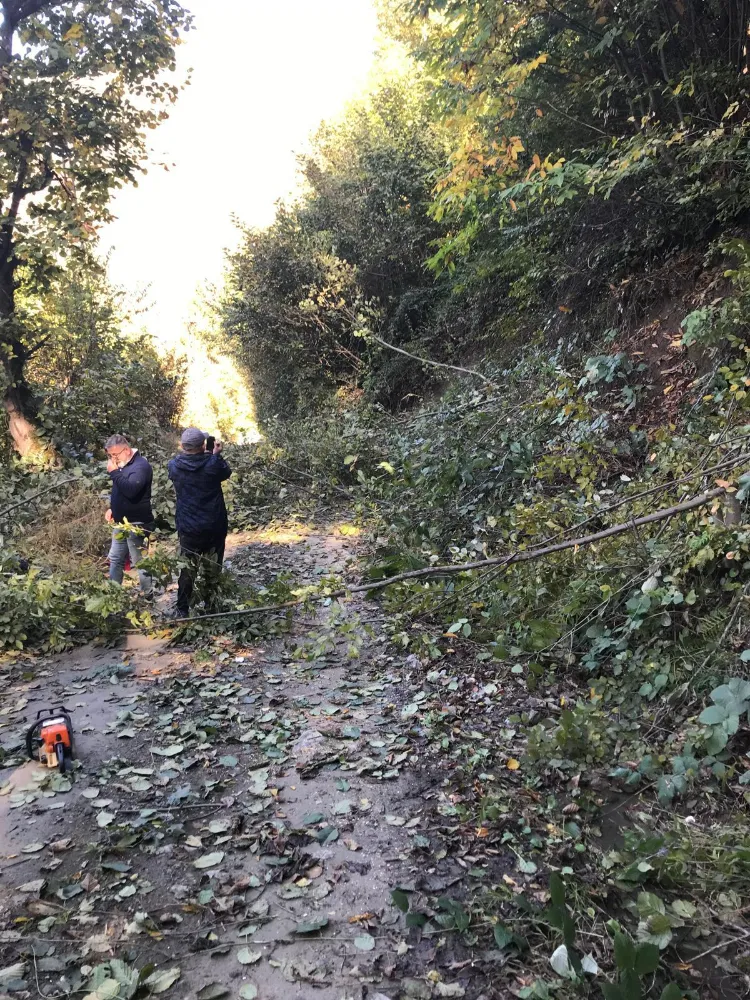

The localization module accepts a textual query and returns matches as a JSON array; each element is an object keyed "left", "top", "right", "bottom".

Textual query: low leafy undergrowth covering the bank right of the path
[{"left": 219, "top": 243, "right": 750, "bottom": 1000}]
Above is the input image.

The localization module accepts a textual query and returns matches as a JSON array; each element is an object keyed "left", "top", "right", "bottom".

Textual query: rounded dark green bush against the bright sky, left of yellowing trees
[{"left": 224, "top": 79, "right": 458, "bottom": 420}]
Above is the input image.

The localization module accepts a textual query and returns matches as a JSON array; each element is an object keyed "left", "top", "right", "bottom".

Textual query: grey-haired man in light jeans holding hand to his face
[{"left": 104, "top": 434, "right": 154, "bottom": 597}]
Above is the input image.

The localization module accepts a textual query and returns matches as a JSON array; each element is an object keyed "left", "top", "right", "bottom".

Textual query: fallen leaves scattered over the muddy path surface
[{"left": 0, "top": 534, "right": 640, "bottom": 1000}]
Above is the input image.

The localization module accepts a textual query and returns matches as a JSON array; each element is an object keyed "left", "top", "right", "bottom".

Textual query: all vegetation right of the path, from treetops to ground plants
[{"left": 213, "top": 0, "right": 750, "bottom": 1000}]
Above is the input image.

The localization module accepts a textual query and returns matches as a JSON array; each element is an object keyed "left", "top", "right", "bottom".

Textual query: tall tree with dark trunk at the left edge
[{"left": 0, "top": 0, "right": 191, "bottom": 456}]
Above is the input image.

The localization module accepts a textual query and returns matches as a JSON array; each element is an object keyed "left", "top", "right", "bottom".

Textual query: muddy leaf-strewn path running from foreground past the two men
[{"left": 0, "top": 526, "right": 476, "bottom": 1000}]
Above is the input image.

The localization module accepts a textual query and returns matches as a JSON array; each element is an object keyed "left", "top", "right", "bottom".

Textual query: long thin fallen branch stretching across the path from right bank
[{"left": 166, "top": 486, "right": 725, "bottom": 625}]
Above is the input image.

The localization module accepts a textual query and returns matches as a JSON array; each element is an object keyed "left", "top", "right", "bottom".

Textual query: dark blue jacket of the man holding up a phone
[{"left": 167, "top": 452, "right": 232, "bottom": 536}]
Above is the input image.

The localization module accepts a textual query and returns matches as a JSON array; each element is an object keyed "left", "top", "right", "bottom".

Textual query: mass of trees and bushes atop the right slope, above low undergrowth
[{"left": 224, "top": 0, "right": 750, "bottom": 428}]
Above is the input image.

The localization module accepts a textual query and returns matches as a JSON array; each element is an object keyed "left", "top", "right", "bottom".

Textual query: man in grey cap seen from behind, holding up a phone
[{"left": 167, "top": 427, "right": 232, "bottom": 618}]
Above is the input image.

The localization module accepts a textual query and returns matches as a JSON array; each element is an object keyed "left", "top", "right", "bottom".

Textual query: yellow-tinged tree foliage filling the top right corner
[{"left": 406, "top": 0, "right": 750, "bottom": 306}]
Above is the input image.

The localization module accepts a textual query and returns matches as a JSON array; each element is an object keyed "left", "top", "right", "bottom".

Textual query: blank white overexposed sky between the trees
[{"left": 102, "top": 0, "right": 377, "bottom": 342}]
